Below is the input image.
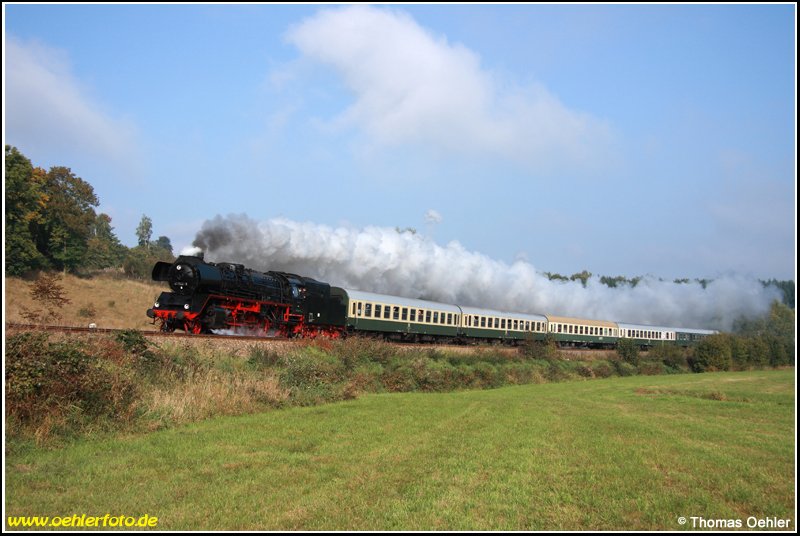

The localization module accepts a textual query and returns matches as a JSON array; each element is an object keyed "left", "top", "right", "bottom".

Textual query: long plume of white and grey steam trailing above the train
[{"left": 194, "top": 215, "right": 779, "bottom": 330}]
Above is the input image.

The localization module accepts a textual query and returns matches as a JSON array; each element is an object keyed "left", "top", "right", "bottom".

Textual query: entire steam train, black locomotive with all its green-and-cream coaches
[{"left": 147, "top": 255, "right": 717, "bottom": 347}]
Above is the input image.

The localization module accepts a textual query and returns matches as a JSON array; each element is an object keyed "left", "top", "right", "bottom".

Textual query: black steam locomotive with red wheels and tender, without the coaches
[{"left": 147, "top": 256, "right": 345, "bottom": 337}]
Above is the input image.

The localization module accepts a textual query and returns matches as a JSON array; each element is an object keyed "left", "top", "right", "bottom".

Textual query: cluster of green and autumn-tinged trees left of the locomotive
[{"left": 5, "top": 145, "right": 175, "bottom": 278}]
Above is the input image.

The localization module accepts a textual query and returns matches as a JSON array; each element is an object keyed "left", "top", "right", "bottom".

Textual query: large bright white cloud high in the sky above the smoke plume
[{"left": 288, "top": 5, "right": 612, "bottom": 174}]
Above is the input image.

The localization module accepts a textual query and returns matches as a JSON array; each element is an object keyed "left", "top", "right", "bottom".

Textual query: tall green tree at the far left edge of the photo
[{"left": 5, "top": 145, "right": 47, "bottom": 275}]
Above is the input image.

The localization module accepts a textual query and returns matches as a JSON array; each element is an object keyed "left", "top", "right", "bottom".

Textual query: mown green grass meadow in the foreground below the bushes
[{"left": 6, "top": 370, "right": 795, "bottom": 531}]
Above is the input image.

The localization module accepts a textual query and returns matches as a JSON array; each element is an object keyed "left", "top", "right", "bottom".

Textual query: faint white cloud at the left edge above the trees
[{"left": 5, "top": 37, "right": 135, "bottom": 163}]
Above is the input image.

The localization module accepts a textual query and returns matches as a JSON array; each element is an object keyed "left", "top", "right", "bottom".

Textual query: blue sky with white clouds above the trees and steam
[{"left": 3, "top": 4, "right": 797, "bottom": 279}]
